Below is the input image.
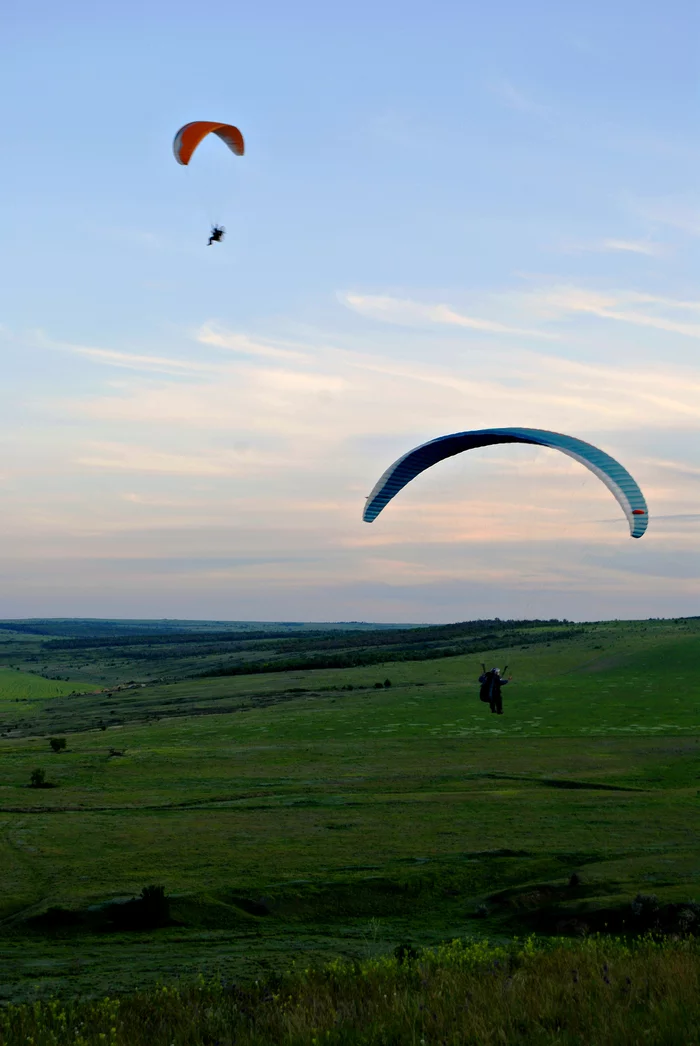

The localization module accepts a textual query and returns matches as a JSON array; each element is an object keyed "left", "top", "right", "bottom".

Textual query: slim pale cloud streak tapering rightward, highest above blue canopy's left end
[{"left": 338, "top": 291, "right": 557, "bottom": 339}]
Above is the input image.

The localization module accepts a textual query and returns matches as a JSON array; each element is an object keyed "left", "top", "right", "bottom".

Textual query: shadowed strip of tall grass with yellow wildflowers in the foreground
[{"left": 0, "top": 937, "right": 700, "bottom": 1046}]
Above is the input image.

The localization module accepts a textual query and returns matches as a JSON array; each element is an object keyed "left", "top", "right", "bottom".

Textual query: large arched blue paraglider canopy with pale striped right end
[{"left": 362, "top": 429, "right": 649, "bottom": 538}]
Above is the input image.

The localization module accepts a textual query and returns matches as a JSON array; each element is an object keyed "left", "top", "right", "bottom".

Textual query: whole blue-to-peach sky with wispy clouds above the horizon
[{"left": 0, "top": 0, "right": 700, "bottom": 622}]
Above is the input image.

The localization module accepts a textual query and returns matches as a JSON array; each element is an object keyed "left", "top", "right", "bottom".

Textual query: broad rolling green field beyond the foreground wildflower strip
[{"left": 0, "top": 619, "right": 700, "bottom": 998}]
